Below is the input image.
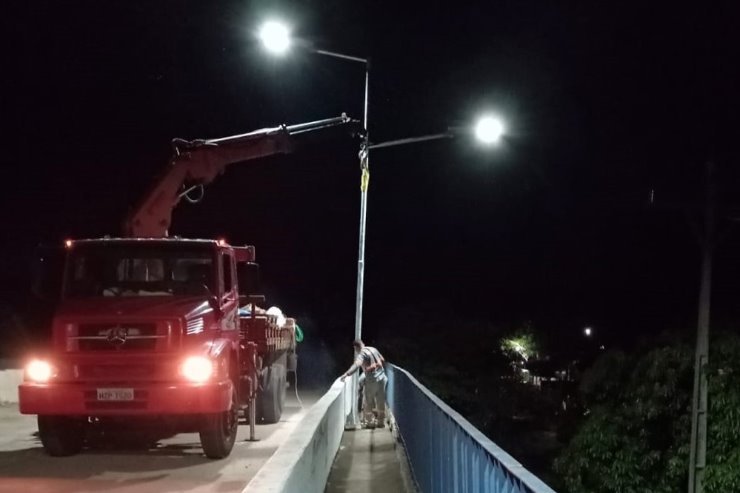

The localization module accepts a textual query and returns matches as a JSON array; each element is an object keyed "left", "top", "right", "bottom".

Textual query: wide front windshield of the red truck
[{"left": 64, "top": 242, "right": 215, "bottom": 298}]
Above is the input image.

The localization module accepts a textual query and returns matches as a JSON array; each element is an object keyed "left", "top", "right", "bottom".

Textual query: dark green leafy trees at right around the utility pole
[{"left": 555, "top": 334, "right": 740, "bottom": 493}]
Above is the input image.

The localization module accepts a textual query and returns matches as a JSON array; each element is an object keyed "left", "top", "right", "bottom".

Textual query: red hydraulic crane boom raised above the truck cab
[{"left": 124, "top": 115, "right": 361, "bottom": 238}]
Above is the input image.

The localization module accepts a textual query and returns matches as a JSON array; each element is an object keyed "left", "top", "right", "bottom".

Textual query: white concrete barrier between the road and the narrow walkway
[{"left": 242, "top": 380, "right": 348, "bottom": 493}]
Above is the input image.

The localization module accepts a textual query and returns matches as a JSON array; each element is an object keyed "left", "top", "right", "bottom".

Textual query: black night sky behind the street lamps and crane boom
[{"left": 0, "top": 0, "right": 740, "bottom": 354}]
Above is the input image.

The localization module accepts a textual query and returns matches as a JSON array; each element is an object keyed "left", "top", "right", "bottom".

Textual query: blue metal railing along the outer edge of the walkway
[{"left": 386, "top": 365, "right": 555, "bottom": 493}]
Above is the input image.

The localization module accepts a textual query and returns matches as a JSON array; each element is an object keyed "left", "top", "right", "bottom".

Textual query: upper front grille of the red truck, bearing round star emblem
[{"left": 70, "top": 323, "right": 166, "bottom": 351}]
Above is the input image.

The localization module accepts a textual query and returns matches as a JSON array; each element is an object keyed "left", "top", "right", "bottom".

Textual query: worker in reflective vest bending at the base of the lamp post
[{"left": 341, "top": 339, "right": 388, "bottom": 428}]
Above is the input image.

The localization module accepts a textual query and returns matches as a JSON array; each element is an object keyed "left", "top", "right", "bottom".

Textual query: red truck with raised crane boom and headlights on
[{"left": 19, "top": 115, "right": 360, "bottom": 459}]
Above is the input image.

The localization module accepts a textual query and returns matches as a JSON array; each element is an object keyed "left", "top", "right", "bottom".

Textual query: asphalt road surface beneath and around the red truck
[{"left": 0, "top": 389, "right": 321, "bottom": 493}]
